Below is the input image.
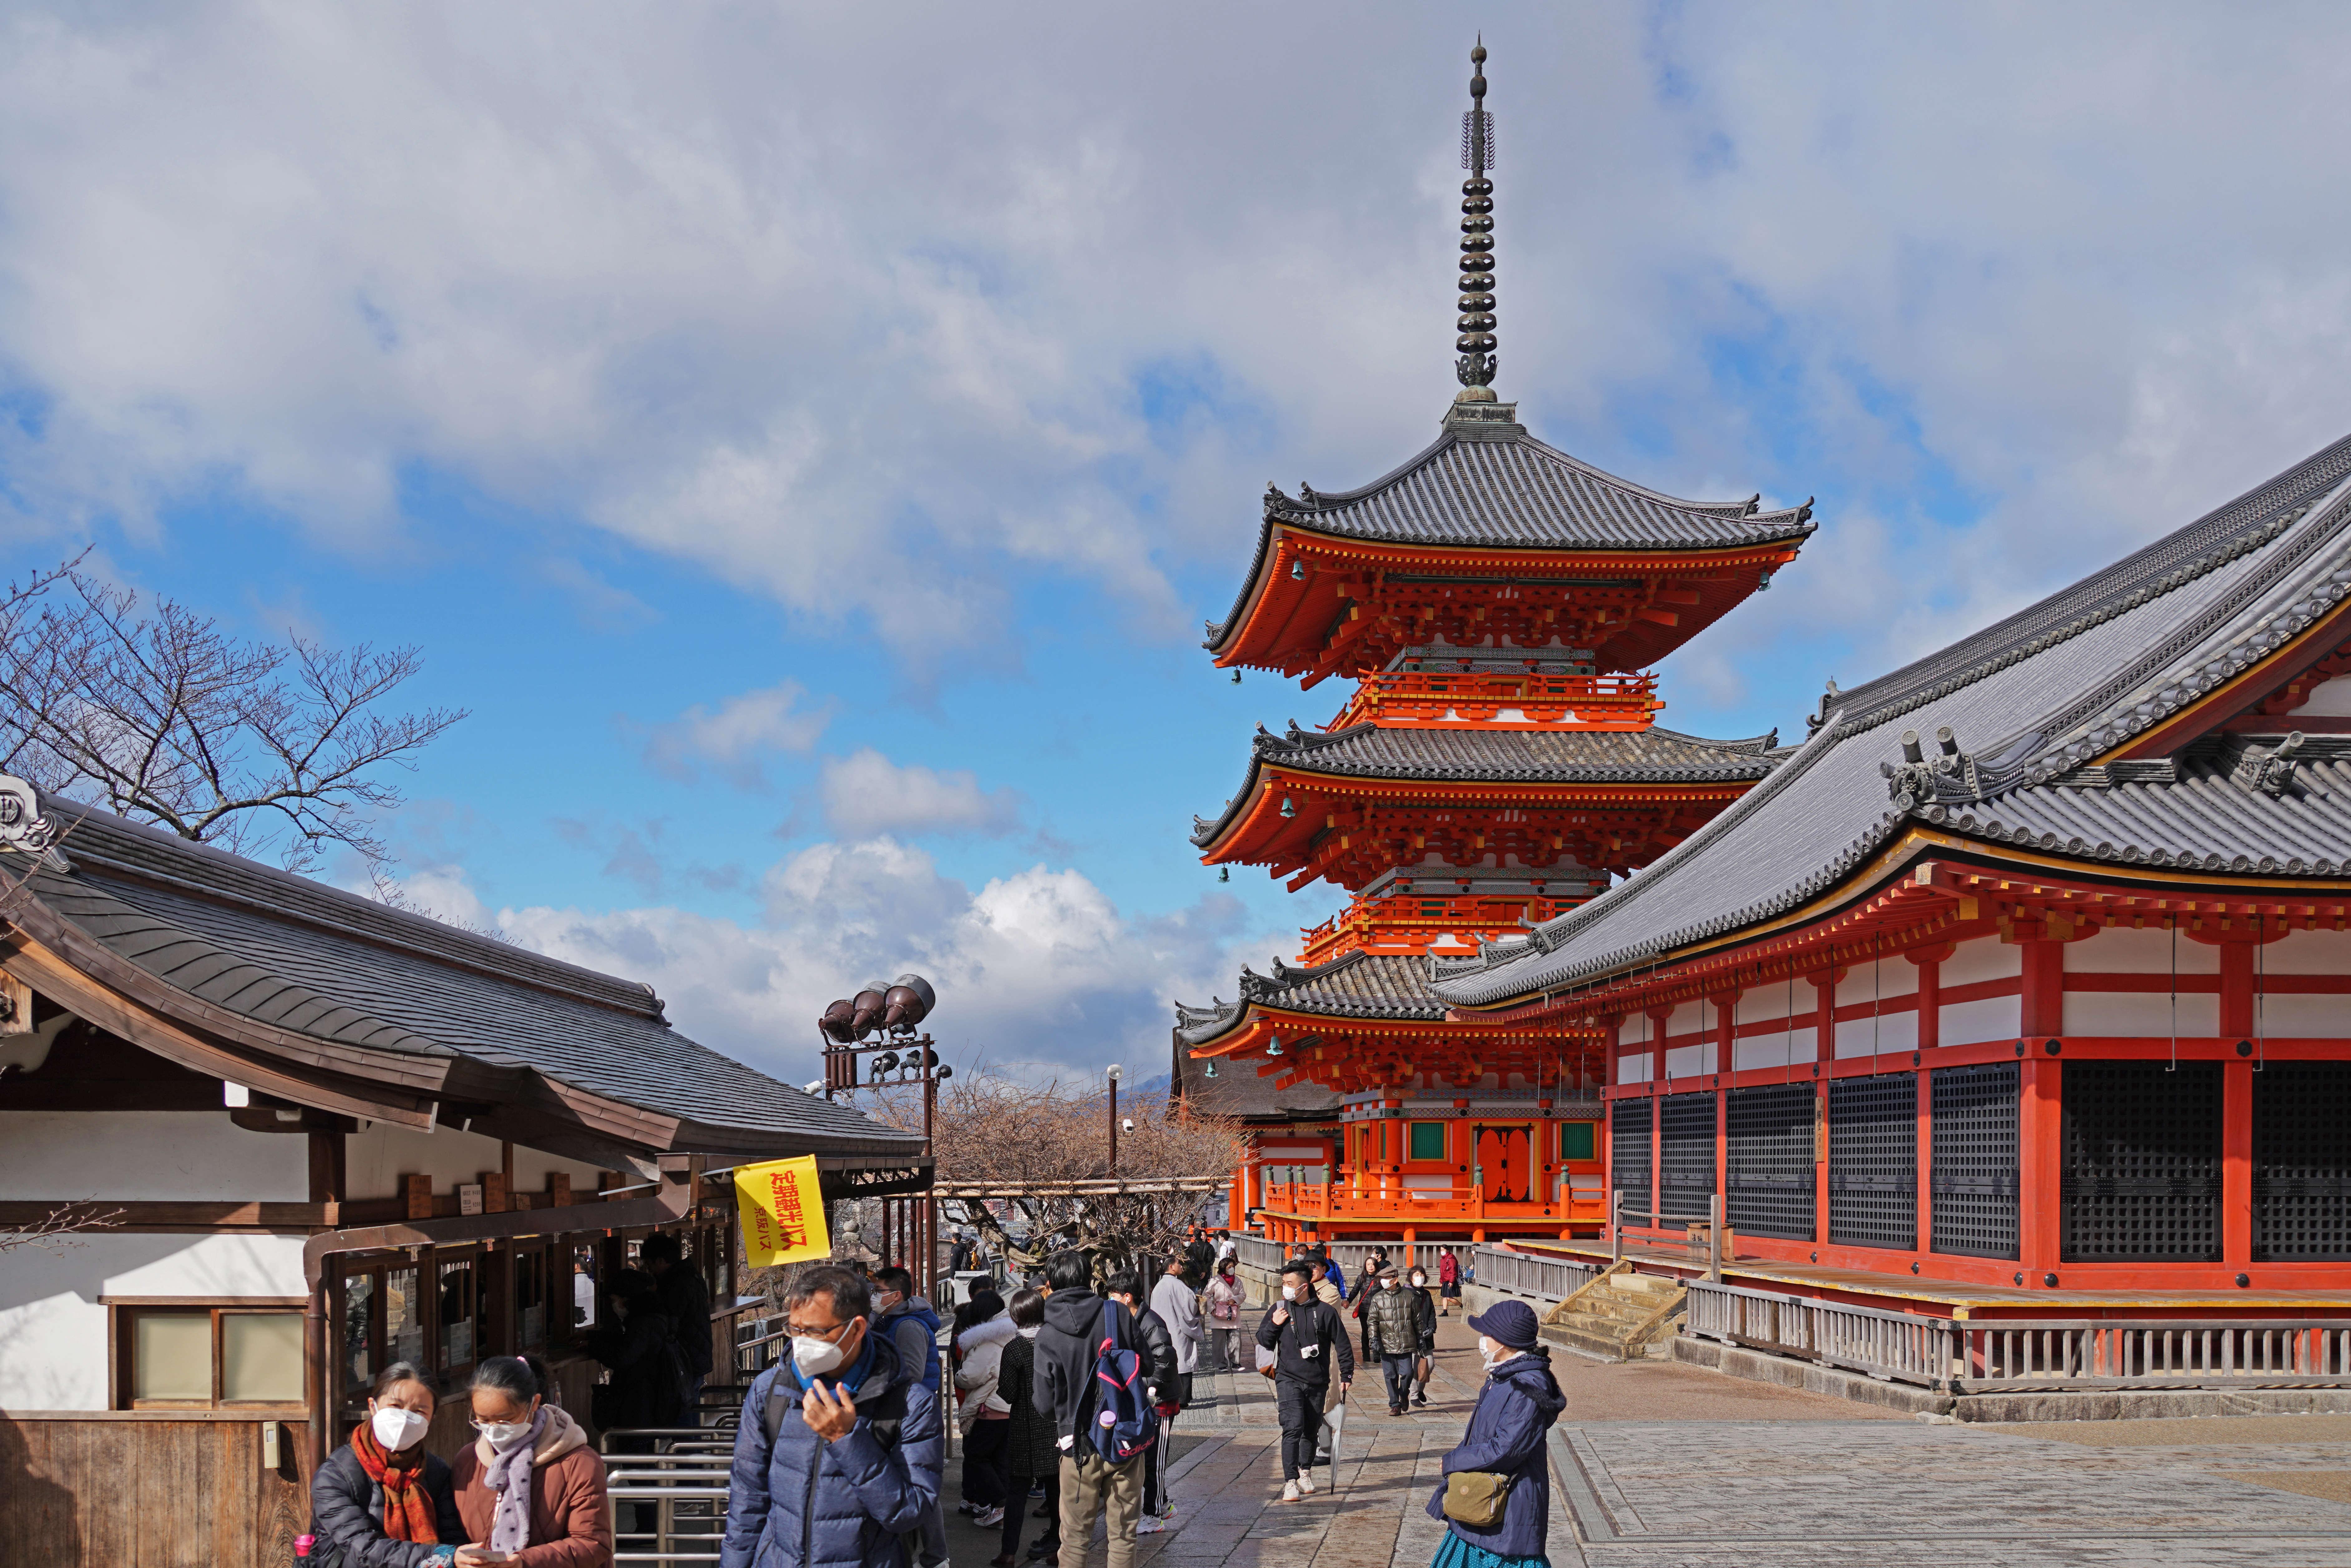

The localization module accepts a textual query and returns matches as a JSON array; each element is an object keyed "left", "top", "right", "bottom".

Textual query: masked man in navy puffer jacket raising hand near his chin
[{"left": 719, "top": 1265, "right": 947, "bottom": 1568}]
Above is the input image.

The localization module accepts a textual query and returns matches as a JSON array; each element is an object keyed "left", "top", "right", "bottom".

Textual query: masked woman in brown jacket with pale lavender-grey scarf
[{"left": 449, "top": 1356, "right": 611, "bottom": 1568}]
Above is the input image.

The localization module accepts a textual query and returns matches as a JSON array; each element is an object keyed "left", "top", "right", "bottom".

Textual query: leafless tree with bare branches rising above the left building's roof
[{"left": 0, "top": 552, "right": 466, "bottom": 870}]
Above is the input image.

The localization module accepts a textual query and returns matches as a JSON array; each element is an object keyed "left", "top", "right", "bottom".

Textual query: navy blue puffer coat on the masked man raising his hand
[{"left": 719, "top": 1333, "right": 947, "bottom": 1568}]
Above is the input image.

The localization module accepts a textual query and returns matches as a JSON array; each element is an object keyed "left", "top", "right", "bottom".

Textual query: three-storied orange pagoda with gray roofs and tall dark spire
[{"left": 1176, "top": 47, "right": 1813, "bottom": 1243}]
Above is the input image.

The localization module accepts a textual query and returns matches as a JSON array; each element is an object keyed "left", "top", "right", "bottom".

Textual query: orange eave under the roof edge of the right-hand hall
[{"left": 1446, "top": 828, "right": 2351, "bottom": 1023}]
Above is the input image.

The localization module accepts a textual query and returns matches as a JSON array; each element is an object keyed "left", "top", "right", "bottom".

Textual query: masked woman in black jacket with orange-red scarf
[{"left": 310, "top": 1361, "right": 466, "bottom": 1568}]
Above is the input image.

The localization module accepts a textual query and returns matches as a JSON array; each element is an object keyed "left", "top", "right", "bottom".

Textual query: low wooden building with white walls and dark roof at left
[{"left": 0, "top": 799, "right": 929, "bottom": 1566}]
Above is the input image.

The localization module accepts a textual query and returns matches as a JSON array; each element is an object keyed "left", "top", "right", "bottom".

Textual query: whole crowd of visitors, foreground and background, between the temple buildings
[{"left": 313, "top": 1229, "right": 1566, "bottom": 1568}]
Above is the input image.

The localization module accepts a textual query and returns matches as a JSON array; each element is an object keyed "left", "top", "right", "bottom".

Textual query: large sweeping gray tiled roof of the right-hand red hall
[{"left": 1436, "top": 440, "right": 2351, "bottom": 1006}]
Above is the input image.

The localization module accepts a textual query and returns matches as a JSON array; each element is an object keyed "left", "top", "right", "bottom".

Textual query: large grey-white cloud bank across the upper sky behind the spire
[{"left": 0, "top": 0, "right": 2351, "bottom": 693}]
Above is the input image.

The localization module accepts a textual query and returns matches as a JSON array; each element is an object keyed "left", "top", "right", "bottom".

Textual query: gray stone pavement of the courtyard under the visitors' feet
[{"left": 950, "top": 1319, "right": 2351, "bottom": 1568}]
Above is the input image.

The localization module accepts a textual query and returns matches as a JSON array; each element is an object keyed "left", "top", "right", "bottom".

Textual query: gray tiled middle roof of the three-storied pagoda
[{"left": 1192, "top": 719, "right": 1784, "bottom": 846}]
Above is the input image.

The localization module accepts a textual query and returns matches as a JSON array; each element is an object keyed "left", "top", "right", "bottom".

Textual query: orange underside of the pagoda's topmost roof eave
[{"left": 1208, "top": 531, "right": 1803, "bottom": 684}]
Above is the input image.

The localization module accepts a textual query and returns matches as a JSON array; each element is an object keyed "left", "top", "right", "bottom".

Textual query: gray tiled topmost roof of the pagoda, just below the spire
[{"left": 1208, "top": 432, "right": 1815, "bottom": 647}]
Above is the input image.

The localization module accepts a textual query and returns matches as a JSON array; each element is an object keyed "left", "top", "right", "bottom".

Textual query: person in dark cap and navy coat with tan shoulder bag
[{"left": 1430, "top": 1300, "right": 1568, "bottom": 1568}]
